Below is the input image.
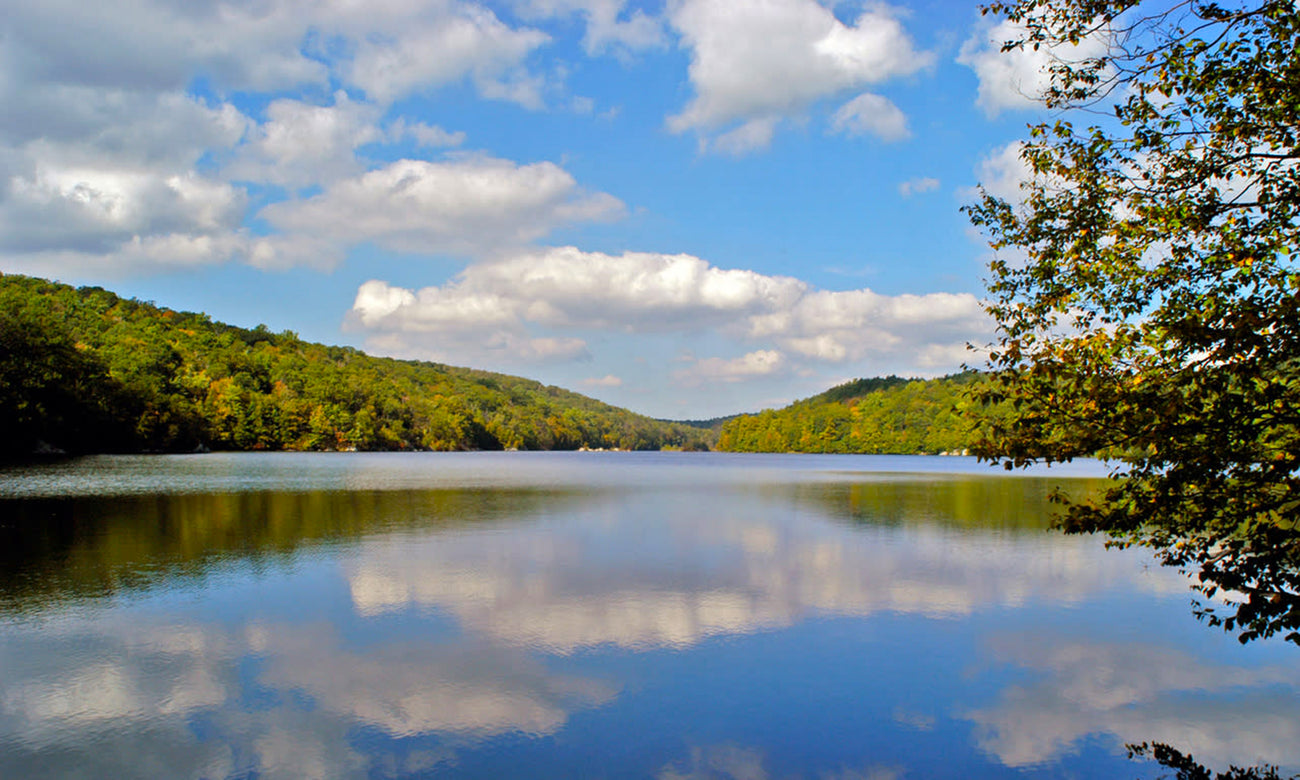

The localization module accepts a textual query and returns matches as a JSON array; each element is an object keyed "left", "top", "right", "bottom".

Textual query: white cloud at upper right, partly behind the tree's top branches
[{"left": 957, "top": 20, "right": 1110, "bottom": 117}]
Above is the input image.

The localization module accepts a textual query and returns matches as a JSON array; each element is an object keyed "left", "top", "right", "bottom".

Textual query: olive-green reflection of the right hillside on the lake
[{"left": 798, "top": 475, "right": 1105, "bottom": 530}]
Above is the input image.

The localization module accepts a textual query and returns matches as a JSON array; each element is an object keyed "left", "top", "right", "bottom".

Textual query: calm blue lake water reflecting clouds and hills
[{"left": 0, "top": 452, "right": 1300, "bottom": 780}]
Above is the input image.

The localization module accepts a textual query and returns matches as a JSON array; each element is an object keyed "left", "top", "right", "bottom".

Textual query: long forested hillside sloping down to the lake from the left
[{"left": 0, "top": 274, "right": 711, "bottom": 456}]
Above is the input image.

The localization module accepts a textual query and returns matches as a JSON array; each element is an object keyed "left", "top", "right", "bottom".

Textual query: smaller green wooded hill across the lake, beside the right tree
[{"left": 718, "top": 373, "right": 978, "bottom": 454}]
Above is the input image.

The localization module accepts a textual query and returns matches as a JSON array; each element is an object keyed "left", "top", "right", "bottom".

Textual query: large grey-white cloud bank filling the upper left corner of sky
[{"left": 0, "top": 0, "right": 553, "bottom": 274}]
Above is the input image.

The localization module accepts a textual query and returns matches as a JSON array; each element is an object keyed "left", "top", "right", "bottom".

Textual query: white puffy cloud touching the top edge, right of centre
[{"left": 668, "top": 0, "right": 931, "bottom": 151}]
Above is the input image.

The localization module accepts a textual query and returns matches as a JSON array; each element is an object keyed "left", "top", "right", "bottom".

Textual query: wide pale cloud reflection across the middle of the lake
[{"left": 350, "top": 482, "right": 1184, "bottom": 653}]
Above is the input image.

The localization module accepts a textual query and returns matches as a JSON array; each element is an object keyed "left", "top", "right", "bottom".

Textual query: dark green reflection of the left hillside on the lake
[{"left": 0, "top": 489, "right": 580, "bottom": 611}]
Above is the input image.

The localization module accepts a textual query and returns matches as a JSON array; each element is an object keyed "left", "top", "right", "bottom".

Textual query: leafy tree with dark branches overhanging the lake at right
[{"left": 970, "top": 0, "right": 1300, "bottom": 642}]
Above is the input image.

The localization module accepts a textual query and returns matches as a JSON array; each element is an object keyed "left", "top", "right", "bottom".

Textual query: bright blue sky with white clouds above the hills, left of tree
[{"left": 0, "top": 0, "right": 1087, "bottom": 419}]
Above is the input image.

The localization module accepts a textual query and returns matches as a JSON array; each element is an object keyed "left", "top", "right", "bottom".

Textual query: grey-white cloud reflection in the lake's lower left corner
[{"left": 0, "top": 614, "right": 618, "bottom": 777}]
